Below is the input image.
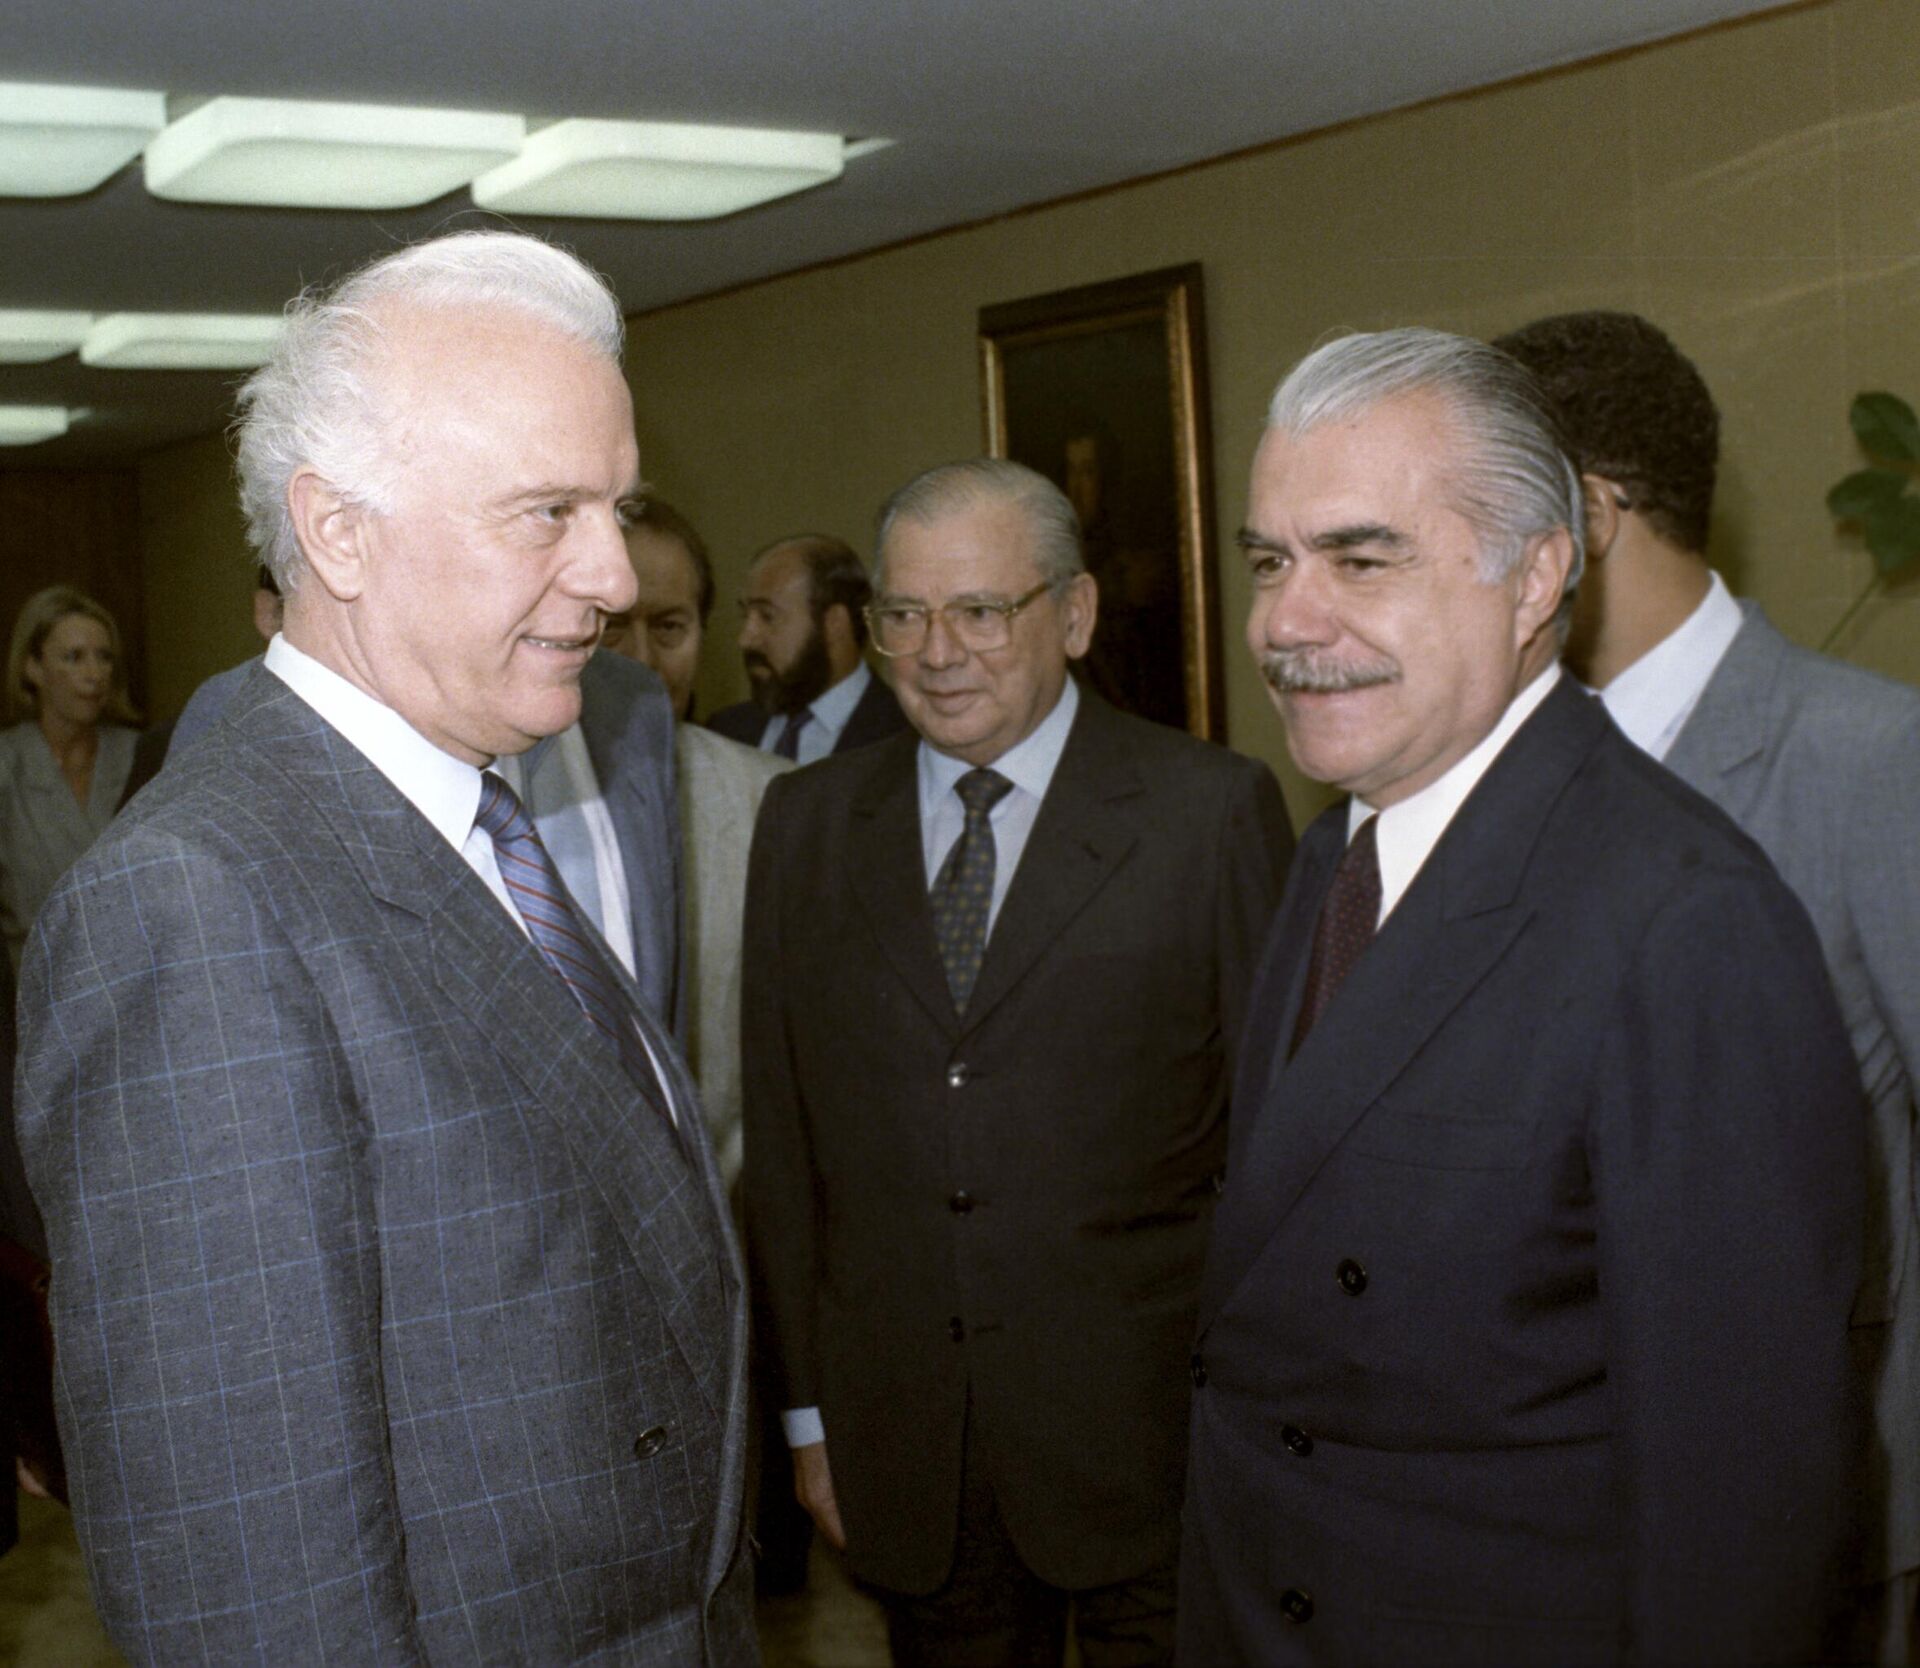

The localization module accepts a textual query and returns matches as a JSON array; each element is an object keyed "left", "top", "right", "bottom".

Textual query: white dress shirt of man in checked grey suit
[{"left": 267, "top": 635, "right": 680, "bottom": 1123}]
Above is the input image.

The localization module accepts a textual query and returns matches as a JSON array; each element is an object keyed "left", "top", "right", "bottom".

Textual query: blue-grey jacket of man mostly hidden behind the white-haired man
[{"left": 167, "top": 651, "right": 687, "bottom": 1037}]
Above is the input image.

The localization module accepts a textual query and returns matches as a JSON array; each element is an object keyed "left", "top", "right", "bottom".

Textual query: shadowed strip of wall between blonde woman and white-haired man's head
[{"left": 140, "top": 434, "right": 261, "bottom": 720}]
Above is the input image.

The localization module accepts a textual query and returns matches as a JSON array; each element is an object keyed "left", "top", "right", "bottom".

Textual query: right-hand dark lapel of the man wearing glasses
[{"left": 960, "top": 691, "right": 1144, "bottom": 1031}]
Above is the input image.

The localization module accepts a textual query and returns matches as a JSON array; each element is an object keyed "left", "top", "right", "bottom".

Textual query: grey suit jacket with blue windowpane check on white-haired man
[{"left": 17, "top": 668, "right": 756, "bottom": 1664}]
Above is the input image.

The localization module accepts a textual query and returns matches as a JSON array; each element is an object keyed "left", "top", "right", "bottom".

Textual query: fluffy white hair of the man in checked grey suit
[{"left": 232, "top": 232, "right": 626, "bottom": 595}]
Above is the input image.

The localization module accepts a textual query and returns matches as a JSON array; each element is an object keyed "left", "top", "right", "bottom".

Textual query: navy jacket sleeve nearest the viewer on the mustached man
[{"left": 1588, "top": 868, "right": 1864, "bottom": 1662}]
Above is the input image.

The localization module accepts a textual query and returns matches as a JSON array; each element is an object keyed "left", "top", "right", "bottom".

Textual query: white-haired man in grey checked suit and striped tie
[{"left": 19, "top": 232, "right": 756, "bottom": 1668}]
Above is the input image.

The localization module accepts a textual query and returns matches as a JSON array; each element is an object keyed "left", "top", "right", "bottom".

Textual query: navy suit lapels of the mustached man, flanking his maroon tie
[{"left": 1200, "top": 679, "right": 1607, "bottom": 1326}]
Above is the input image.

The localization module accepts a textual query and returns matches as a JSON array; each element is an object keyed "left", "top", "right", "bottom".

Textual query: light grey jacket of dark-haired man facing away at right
[{"left": 1667, "top": 603, "right": 1920, "bottom": 1582}]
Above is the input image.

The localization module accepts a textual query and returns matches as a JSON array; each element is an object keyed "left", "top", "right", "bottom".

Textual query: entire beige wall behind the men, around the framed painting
[{"left": 142, "top": 0, "right": 1920, "bottom": 814}]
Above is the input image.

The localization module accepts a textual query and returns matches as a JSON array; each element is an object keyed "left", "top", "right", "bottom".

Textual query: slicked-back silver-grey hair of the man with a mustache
[{"left": 1267, "top": 330, "right": 1586, "bottom": 602}]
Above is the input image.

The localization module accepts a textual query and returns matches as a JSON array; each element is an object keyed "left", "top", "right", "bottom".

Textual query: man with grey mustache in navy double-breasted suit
[{"left": 1181, "top": 330, "right": 1864, "bottom": 1664}]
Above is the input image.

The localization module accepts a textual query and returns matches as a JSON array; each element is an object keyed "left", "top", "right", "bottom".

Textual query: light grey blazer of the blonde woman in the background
[{"left": 0, "top": 720, "right": 140, "bottom": 969}]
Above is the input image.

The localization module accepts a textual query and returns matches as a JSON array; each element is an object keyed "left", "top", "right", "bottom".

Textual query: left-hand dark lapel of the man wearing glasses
[{"left": 847, "top": 731, "right": 960, "bottom": 1033}]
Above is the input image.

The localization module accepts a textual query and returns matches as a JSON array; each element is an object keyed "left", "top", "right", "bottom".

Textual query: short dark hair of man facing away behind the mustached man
[{"left": 1494, "top": 313, "right": 1720, "bottom": 555}]
